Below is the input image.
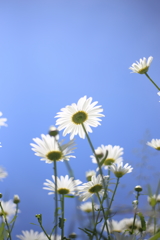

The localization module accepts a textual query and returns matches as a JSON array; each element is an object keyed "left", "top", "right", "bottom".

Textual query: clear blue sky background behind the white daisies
[{"left": 0, "top": 0, "right": 160, "bottom": 238}]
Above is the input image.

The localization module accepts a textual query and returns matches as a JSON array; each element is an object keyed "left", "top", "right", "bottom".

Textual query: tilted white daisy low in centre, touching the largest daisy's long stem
[{"left": 78, "top": 174, "right": 110, "bottom": 201}]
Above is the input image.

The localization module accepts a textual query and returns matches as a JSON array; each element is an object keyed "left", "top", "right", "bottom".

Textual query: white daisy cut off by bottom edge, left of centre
[{"left": 16, "top": 230, "right": 53, "bottom": 240}]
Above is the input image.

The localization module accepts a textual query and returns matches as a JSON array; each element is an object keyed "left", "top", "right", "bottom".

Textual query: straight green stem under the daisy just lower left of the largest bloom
[{"left": 54, "top": 161, "right": 58, "bottom": 240}]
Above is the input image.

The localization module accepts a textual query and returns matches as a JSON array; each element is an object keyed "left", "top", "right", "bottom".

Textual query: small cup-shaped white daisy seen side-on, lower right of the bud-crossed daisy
[{"left": 109, "top": 162, "right": 133, "bottom": 178}]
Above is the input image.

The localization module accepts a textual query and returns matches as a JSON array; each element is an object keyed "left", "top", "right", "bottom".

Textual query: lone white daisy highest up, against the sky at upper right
[{"left": 129, "top": 57, "right": 153, "bottom": 74}]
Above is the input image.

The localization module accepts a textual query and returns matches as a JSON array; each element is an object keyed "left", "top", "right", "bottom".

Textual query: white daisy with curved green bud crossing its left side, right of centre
[{"left": 90, "top": 145, "right": 123, "bottom": 169}]
